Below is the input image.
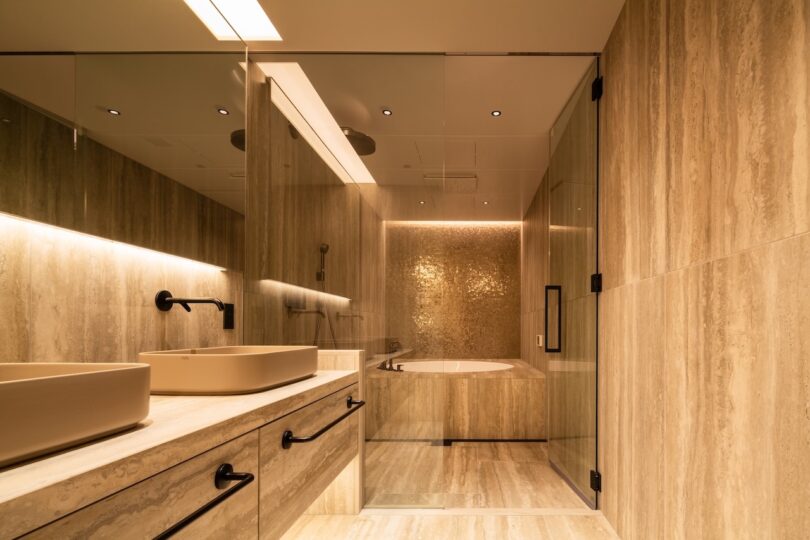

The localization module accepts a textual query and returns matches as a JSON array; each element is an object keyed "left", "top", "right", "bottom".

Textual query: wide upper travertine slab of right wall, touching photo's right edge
[{"left": 667, "top": 0, "right": 810, "bottom": 269}]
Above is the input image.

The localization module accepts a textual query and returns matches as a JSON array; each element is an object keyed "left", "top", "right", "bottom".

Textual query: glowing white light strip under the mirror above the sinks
[{"left": 0, "top": 212, "right": 226, "bottom": 272}]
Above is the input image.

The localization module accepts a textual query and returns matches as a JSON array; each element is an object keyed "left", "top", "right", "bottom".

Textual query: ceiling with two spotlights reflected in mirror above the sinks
[{"left": 0, "top": 53, "right": 245, "bottom": 213}]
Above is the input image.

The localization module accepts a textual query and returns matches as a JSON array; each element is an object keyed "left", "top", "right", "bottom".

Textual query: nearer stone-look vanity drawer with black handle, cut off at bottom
[{"left": 25, "top": 431, "right": 259, "bottom": 540}]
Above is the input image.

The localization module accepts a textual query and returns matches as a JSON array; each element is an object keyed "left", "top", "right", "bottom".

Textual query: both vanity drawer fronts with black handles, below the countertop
[{"left": 18, "top": 384, "right": 360, "bottom": 540}]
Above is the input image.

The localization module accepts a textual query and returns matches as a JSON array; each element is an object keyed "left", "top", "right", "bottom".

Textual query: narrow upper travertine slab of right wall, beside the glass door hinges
[{"left": 599, "top": 0, "right": 668, "bottom": 289}]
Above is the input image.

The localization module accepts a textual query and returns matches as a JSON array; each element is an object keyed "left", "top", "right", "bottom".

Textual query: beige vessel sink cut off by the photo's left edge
[{"left": 0, "top": 363, "right": 149, "bottom": 467}]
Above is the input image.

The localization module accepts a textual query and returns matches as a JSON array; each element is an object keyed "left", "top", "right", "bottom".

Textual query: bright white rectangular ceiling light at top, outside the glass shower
[{"left": 185, "top": 0, "right": 281, "bottom": 41}]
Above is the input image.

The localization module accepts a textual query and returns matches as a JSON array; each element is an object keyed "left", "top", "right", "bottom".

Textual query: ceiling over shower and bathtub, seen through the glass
[{"left": 260, "top": 54, "right": 594, "bottom": 220}]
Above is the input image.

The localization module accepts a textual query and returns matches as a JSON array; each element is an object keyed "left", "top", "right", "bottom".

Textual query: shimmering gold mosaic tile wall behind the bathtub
[{"left": 385, "top": 223, "right": 520, "bottom": 358}]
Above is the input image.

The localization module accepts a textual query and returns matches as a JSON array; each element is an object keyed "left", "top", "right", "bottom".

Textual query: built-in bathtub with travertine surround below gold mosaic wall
[{"left": 366, "top": 359, "right": 546, "bottom": 440}]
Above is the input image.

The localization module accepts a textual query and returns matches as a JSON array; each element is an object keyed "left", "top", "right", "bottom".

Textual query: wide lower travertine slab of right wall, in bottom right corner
[{"left": 666, "top": 235, "right": 810, "bottom": 538}]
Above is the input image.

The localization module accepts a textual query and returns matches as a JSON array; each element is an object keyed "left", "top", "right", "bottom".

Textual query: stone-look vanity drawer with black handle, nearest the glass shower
[{"left": 259, "top": 384, "right": 363, "bottom": 539}]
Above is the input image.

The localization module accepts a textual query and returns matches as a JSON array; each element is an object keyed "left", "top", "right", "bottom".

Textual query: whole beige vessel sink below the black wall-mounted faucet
[{"left": 138, "top": 345, "right": 318, "bottom": 395}]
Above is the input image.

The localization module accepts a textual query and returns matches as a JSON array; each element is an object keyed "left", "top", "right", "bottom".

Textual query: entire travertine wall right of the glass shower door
[{"left": 599, "top": 0, "right": 810, "bottom": 538}]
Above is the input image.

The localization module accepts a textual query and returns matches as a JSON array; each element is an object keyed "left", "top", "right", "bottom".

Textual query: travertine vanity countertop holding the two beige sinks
[{"left": 0, "top": 370, "right": 358, "bottom": 538}]
